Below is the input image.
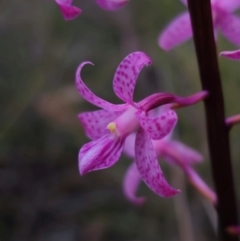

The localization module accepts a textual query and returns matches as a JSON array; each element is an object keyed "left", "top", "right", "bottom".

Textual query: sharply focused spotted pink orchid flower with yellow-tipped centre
[{"left": 76, "top": 52, "right": 179, "bottom": 197}]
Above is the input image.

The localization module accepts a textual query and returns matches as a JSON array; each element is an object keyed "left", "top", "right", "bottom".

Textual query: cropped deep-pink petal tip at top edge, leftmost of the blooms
[{"left": 55, "top": 0, "right": 82, "bottom": 20}]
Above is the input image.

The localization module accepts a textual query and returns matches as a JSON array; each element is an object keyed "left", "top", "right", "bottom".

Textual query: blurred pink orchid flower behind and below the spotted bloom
[{"left": 123, "top": 125, "right": 216, "bottom": 205}]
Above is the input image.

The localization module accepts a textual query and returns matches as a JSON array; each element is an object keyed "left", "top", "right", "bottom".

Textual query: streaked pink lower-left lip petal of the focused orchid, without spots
[{"left": 78, "top": 134, "right": 124, "bottom": 175}]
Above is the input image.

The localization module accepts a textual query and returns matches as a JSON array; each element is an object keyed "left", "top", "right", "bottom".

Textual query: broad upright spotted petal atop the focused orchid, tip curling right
[{"left": 113, "top": 52, "right": 151, "bottom": 106}]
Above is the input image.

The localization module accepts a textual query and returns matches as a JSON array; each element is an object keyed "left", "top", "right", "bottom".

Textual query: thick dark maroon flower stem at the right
[{"left": 188, "top": 0, "right": 238, "bottom": 241}]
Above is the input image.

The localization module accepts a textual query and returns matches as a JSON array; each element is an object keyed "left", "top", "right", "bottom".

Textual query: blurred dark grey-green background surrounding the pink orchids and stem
[{"left": 0, "top": 0, "right": 240, "bottom": 241}]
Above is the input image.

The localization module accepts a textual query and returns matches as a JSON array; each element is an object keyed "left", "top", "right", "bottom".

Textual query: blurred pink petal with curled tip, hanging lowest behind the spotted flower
[{"left": 123, "top": 162, "right": 145, "bottom": 205}]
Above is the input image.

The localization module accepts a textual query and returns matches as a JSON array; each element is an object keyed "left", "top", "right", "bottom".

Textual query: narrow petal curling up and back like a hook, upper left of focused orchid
[{"left": 76, "top": 62, "right": 126, "bottom": 111}]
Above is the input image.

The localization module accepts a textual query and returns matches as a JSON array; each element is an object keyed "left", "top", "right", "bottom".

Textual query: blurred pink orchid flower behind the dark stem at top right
[{"left": 158, "top": 0, "right": 240, "bottom": 51}]
